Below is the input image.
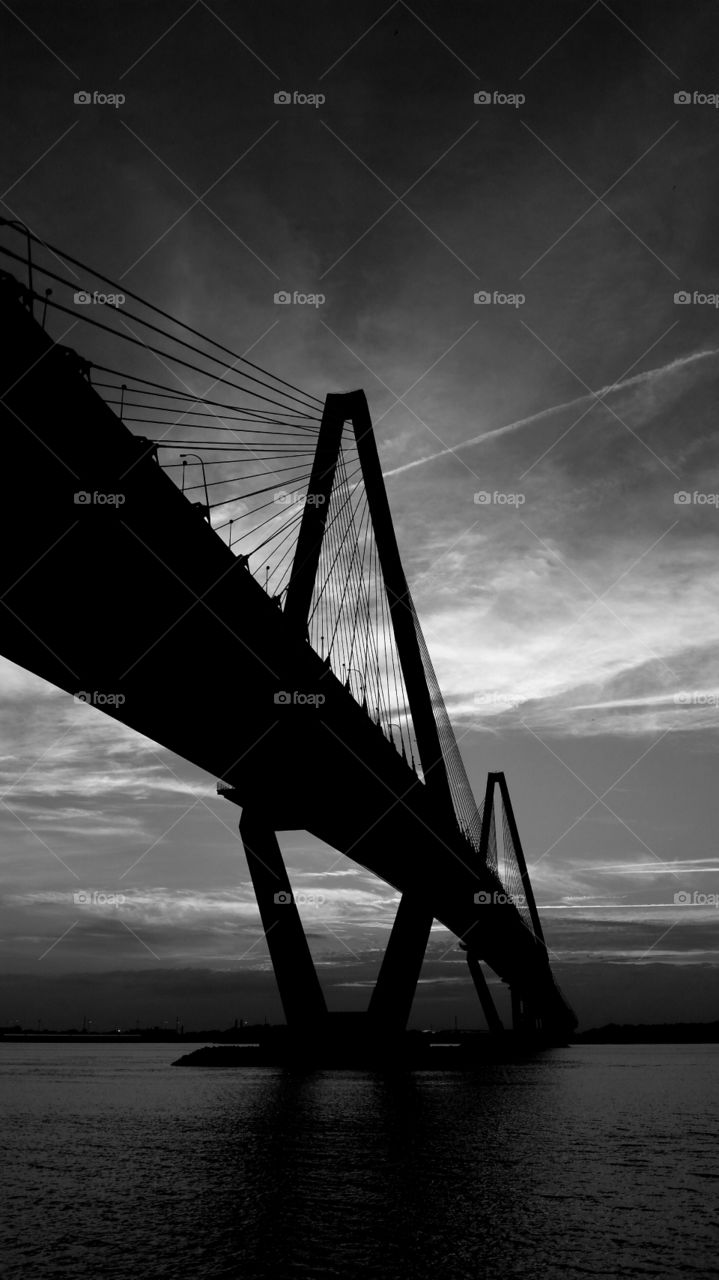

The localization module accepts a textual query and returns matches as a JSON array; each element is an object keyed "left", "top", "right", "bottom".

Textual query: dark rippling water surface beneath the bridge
[{"left": 0, "top": 1044, "right": 719, "bottom": 1280}]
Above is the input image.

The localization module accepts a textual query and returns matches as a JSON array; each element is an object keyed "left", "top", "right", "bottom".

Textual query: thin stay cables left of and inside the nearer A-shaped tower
[{"left": 0, "top": 220, "right": 429, "bottom": 773}]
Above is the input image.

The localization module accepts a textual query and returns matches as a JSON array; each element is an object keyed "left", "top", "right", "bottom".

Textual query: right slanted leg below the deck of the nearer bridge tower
[{"left": 367, "top": 893, "right": 434, "bottom": 1033}]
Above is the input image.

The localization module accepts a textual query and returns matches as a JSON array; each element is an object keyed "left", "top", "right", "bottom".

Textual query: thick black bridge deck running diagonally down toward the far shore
[{"left": 0, "top": 276, "right": 565, "bottom": 1023}]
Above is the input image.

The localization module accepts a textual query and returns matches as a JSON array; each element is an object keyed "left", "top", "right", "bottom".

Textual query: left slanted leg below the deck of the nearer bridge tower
[{"left": 239, "top": 810, "right": 328, "bottom": 1030}]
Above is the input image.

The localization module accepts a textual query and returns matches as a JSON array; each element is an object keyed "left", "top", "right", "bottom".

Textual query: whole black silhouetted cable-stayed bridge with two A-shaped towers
[{"left": 0, "top": 220, "right": 576, "bottom": 1043}]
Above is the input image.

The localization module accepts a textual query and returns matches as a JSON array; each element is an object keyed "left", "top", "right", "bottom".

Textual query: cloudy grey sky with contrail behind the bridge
[{"left": 0, "top": 0, "right": 719, "bottom": 1028}]
